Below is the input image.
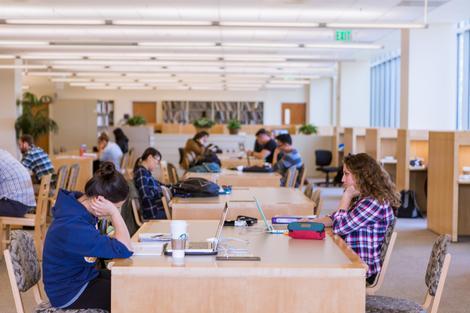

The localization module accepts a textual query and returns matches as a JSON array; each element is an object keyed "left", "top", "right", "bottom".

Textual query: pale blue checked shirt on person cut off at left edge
[{"left": 0, "top": 149, "right": 36, "bottom": 207}]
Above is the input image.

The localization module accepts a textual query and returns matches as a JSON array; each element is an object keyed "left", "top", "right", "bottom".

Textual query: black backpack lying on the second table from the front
[{"left": 171, "top": 177, "right": 220, "bottom": 198}]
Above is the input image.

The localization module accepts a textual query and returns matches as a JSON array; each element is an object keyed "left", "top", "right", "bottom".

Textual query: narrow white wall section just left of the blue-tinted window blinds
[{"left": 340, "top": 61, "right": 370, "bottom": 127}]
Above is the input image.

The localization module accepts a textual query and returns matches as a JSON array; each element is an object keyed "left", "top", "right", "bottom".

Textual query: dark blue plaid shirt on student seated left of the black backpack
[{"left": 134, "top": 166, "right": 164, "bottom": 219}]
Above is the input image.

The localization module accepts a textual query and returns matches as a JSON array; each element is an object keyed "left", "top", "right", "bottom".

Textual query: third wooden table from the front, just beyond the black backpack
[{"left": 185, "top": 169, "right": 282, "bottom": 187}]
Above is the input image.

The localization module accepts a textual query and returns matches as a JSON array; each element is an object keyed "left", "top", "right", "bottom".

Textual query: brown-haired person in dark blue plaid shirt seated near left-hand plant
[{"left": 18, "top": 135, "right": 54, "bottom": 183}]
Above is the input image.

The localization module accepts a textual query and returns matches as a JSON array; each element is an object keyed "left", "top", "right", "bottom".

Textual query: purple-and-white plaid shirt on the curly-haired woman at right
[{"left": 330, "top": 197, "right": 395, "bottom": 277}]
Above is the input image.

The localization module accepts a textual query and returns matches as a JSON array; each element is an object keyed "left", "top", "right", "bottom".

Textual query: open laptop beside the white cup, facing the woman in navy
[{"left": 163, "top": 202, "right": 228, "bottom": 255}]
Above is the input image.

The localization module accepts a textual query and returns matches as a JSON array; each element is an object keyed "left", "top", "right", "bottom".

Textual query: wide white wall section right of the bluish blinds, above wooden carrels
[{"left": 408, "top": 24, "right": 457, "bottom": 130}]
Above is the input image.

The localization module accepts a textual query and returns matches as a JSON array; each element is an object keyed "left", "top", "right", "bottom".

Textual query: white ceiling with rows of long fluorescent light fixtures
[{"left": 0, "top": 0, "right": 447, "bottom": 90}]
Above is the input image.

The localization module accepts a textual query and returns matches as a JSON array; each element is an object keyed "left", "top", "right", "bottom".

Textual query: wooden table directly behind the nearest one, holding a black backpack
[{"left": 171, "top": 187, "right": 316, "bottom": 220}]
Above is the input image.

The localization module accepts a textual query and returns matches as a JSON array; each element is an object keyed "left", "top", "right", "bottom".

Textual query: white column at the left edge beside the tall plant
[{"left": 0, "top": 60, "right": 21, "bottom": 157}]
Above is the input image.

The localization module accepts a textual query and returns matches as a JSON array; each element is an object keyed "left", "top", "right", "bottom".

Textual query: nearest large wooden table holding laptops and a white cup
[{"left": 111, "top": 220, "right": 367, "bottom": 313}]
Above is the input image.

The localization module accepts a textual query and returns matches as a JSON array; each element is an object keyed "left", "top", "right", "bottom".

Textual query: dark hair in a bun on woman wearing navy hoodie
[{"left": 85, "top": 162, "right": 129, "bottom": 203}]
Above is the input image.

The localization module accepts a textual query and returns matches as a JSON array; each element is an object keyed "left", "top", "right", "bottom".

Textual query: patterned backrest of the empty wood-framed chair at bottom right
[{"left": 423, "top": 235, "right": 451, "bottom": 313}]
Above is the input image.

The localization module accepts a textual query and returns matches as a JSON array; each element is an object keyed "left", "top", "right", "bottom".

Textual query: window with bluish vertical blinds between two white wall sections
[{"left": 370, "top": 55, "right": 400, "bottom": 128}]
